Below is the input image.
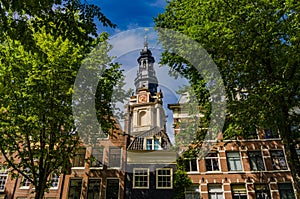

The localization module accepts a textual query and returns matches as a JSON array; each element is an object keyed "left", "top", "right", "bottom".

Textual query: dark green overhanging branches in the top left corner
[{"left": 0, "top": 0, "right": 115, "bottom": 52}]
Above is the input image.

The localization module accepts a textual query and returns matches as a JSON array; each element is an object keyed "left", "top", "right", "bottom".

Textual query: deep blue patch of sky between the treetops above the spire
[{"left": 87, "top": 0, "right": 166, "bottom": 35}]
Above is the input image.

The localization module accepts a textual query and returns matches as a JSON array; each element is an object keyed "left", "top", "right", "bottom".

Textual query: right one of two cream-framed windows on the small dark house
[{"left": 156, "top": 168, "right": 173, "bottom": 189}]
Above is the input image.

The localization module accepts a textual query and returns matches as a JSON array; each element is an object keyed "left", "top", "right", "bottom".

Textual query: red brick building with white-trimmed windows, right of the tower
[{"left": 168, "top": 96, "right": 295, "bottom": 199}]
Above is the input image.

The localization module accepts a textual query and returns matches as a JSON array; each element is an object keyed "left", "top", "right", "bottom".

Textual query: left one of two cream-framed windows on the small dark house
[{"left": 133, "top": 168, "right": 149, "bottom": 188}]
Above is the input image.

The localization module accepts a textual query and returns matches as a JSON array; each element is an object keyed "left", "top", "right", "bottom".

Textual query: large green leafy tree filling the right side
[{"left": 155, "top": 0, "right": 300, "bottom": 194}]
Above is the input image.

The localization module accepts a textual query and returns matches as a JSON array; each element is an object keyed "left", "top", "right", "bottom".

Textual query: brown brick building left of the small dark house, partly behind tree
[{"left": 0, "top": 128, "right": 127, "bottom": 199}]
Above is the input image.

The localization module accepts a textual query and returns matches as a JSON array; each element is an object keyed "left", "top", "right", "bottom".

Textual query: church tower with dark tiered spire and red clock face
[{"left": 125, "top": 41, "right": 166, "bottom": 136}]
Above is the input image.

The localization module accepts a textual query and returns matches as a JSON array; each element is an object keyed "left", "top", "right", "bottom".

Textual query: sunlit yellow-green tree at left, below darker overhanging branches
[{"left": 0, "top": 22, "right": 82, "bottom": 199}]
